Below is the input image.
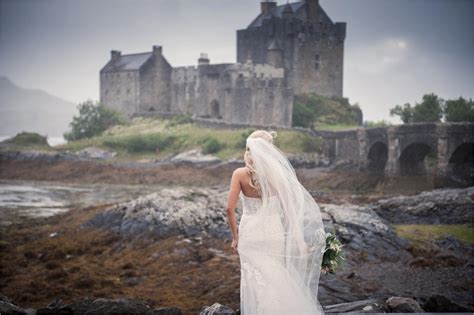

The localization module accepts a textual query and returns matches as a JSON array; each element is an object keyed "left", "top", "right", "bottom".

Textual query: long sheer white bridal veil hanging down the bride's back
[{"left": 247, "top": 138, "right": 326, "bottom": 314}]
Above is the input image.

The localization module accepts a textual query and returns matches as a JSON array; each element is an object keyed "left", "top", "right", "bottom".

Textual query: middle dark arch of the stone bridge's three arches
[{"left": 398, "top": 142, "right": 437, "bottom": 176}]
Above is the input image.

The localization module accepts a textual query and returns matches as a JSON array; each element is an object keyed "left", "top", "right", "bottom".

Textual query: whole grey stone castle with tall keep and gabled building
[{"left": 100, "top": 0, "right": 346, "bottom": 127}]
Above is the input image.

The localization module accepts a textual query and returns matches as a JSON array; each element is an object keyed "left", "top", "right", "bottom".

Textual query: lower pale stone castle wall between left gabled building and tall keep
[{"left": 171, "top": 63, "right": 293, "bottom": 126}]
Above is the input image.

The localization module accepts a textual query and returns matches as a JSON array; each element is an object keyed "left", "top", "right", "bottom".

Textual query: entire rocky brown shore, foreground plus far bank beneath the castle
[{"left": 0, "top": 152, "right": 474, "bottom": 314}]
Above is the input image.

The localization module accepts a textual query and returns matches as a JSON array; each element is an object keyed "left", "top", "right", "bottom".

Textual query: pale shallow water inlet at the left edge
[{"left": 0, "top": 180, "right": 160, "bottom": 226}]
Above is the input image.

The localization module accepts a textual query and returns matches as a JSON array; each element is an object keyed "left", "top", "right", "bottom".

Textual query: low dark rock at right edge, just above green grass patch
[{"left": 371, "top": 187, "right": 474, "bottom": 224}]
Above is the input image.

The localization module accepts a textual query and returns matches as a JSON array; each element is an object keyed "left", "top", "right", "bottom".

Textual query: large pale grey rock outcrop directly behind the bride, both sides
[{"left": 84, "top": 187, "right": 407, "bottom": 260}]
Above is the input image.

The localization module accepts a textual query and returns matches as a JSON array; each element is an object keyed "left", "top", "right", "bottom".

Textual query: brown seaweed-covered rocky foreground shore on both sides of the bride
[{"left": 0, "top": 187, "right": 474, "bottom": 314}]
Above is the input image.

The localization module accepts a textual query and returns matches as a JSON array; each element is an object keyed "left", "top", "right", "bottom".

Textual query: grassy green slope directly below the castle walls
[{"left": 55, "top": 117, "right": 321, "bottom": 160}]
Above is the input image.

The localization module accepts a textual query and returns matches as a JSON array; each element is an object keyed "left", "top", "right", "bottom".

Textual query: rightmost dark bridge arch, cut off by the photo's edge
[{"left": 448, "top": 142, "right": 474, "bottom": 185}]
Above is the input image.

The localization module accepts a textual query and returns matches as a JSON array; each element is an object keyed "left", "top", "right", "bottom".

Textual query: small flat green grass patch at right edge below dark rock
[{"left": 394, "top": 223, "right": 474, "bottom": 245}]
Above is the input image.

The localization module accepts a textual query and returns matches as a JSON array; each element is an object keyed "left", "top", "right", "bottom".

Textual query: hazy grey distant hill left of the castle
[{"left": 0, "top": 76, "right": 77, "bottom": 137}]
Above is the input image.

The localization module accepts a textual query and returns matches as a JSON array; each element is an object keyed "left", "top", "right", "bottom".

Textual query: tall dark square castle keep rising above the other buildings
[{"left": 237, "top": 0, "right": 346, "bottom": 96}]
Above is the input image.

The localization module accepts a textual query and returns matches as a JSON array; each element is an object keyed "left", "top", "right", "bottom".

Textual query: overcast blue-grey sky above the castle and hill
[{"left": 0, "top": 0, "right": 474, "bottom": 121}]
